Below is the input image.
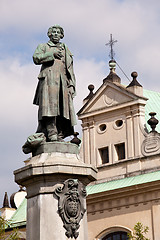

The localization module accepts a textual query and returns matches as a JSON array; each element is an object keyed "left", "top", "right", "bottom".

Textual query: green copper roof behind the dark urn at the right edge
[{"left": 143, "top": 89, "right": 160, "bottom": 132}]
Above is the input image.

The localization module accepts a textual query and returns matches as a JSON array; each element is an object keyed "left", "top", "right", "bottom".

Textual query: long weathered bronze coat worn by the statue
[{"left": 33, "top": 41, "right": 76, "bottom": 136}]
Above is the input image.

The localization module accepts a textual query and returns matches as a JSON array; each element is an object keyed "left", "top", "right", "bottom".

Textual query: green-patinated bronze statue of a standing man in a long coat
[{"left": 33, "top": 25, "right": 76, "bottom": 142}]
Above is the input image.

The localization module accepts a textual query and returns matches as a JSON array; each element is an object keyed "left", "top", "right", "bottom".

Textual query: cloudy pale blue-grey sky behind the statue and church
[{"left": 0, "top": 0, "right": 160, "bottom": 207}]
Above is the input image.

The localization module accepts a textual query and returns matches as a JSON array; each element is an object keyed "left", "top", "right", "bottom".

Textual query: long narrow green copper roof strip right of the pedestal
[{"left": 87, "top": 171, "right": 160, "bottom": 195}]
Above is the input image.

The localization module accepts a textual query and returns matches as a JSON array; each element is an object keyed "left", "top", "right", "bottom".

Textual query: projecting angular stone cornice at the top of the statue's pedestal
[{"left": 14, "top": 145, "right": 97, "bottom": 198}]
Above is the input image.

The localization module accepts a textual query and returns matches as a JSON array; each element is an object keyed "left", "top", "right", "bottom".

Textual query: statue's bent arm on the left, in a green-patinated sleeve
[{"left": 33, "top": 44, "right": 54, "bottom": 64}]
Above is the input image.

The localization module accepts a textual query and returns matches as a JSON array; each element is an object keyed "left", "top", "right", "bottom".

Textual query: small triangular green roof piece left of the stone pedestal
[{"left": 9, "top": 198, "right": 27, "bottom": 227}]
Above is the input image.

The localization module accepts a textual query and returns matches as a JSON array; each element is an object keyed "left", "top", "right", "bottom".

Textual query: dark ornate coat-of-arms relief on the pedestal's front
[{"left": 55, "top": 179, "right": 86, "bottom": 239}]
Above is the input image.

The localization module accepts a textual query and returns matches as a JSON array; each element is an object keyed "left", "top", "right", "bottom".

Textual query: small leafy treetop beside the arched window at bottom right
[{"left": 128, "top": 222, "right": 149, "bottom": 240}]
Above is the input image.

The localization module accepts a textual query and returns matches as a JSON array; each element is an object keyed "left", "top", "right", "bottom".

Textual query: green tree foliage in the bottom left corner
[{"left": 0, "top": 216, "right": 20, "bottom": 240}]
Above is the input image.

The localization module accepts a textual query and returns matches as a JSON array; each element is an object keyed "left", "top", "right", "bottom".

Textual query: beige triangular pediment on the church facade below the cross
[{"left": 78, "top": 82, "right": 141, "bottom": 115}]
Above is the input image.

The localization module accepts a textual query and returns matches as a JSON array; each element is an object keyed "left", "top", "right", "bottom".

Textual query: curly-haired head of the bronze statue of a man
[{"left": 47, "top": 24, "right": 64, "bottom": 42}]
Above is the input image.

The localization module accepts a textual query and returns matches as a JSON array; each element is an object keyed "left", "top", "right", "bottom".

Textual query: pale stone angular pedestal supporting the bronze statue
[{"left": 14, "top": 143, "right": 96, "bottom": 240}]
